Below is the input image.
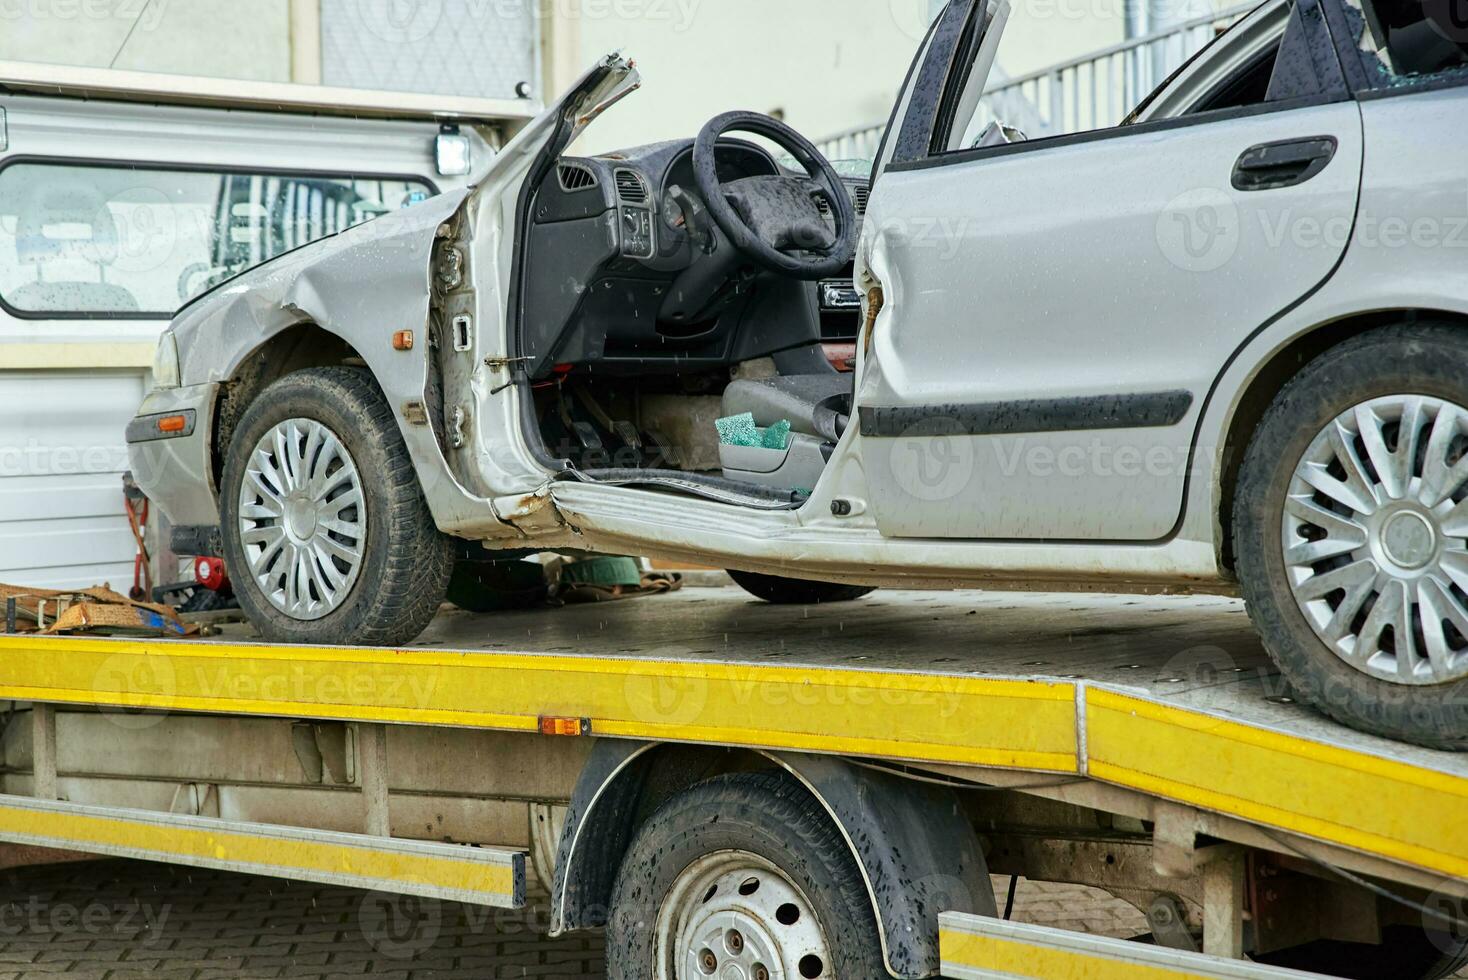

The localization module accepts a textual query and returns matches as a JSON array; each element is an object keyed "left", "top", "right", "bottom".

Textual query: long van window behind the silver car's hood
[{"left": 0, "top": 161, "right": 435, "bottom": 318}]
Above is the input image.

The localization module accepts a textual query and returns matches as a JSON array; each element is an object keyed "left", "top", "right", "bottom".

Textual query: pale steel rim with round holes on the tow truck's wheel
[{"left": 658, "top": 851, "right": 835, "bottom": 980}]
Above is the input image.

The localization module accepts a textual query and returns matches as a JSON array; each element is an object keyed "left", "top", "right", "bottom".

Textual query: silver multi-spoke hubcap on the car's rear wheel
[{"left": 1283, "top": 395, "right": 1468, "bottom": 684}]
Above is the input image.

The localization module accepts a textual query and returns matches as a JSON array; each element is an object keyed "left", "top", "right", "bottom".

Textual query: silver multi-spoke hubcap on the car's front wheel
[{"left": 239, "top": 418, "right": 367, "bottom": 621}]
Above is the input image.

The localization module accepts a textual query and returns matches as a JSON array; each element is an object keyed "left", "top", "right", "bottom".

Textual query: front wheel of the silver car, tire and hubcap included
[{"left": 220, "top": 367, "right": 454, "bottom": 647}]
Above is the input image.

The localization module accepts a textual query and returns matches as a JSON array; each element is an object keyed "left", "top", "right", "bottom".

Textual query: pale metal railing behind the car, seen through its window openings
[{"left": 818, "top": 3, "right": 1257, "bottom": 160}]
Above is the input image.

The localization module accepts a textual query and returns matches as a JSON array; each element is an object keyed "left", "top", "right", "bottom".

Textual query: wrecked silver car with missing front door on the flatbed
[{"left": 131, "top": 0, "right": 1468, "bottom": 750}]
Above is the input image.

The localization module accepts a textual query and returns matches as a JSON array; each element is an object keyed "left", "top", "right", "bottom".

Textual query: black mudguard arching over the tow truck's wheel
[{"left": 551, "top": 739, "right": 997, "bottom": 980}]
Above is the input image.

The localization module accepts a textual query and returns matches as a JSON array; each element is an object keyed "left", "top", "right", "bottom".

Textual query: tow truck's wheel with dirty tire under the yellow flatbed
[{"left": 606, "top": 773, "right": 887, "bottom": 980}]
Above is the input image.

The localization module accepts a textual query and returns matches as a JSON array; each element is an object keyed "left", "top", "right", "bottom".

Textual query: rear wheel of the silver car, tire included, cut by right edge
[{"left": 1233, "top": 324, "right": 1468, "bottom": 751}]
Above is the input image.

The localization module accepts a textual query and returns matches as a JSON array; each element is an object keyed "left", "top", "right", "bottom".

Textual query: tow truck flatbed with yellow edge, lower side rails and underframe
[{"left": 0, "top": 588, "right": 1468, "bottom": 977}]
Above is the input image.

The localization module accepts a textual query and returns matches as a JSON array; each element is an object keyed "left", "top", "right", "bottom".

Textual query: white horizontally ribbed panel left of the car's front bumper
[{"left": 0, "top": 371, "right": 145, "bottom": 593}]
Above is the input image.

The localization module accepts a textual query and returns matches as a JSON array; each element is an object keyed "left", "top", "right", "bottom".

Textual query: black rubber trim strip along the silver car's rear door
[{"left": 860, "top": 392, "right": 1193, "bottom": 439}]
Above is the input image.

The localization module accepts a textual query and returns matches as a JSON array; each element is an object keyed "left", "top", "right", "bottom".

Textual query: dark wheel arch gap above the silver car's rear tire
[{"left": 1214, "top": 307, "right": 1468, "bottom": 572}]
